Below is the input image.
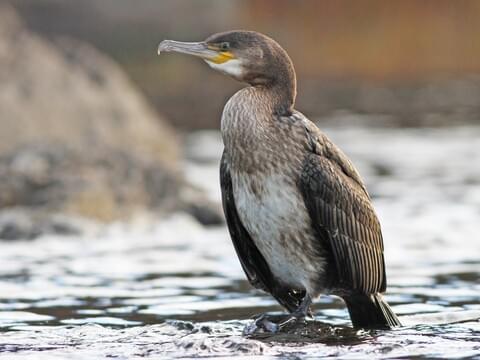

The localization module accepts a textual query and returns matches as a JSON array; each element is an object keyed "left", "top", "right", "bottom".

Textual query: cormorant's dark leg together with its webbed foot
[{"left": 243, "top": 294, "right": 312, "bottom": 335}]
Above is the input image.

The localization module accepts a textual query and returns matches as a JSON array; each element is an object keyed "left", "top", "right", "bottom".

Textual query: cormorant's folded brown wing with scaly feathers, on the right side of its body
[{"left": 299, "top": 124, "right": 386, "bottom": 294}]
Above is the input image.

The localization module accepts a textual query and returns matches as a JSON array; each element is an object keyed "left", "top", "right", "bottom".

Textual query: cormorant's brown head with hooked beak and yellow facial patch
[{"left": 158, "top": 30, "right": 295, "bottom": 87}]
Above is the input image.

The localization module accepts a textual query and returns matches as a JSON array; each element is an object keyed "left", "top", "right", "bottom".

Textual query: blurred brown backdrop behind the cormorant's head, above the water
[{"left": 8, "top": 0, "right": 480, "bottom": 130}]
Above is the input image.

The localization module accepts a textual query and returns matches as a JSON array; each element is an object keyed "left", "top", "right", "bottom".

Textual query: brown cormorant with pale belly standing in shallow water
[{"left": 158, "top": 30, "right": 400, "bottom": 330}]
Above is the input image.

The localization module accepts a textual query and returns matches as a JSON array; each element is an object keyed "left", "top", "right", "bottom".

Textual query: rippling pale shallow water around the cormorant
[{"left": 0, "top": 128, "right": 480, "bottom": 359}]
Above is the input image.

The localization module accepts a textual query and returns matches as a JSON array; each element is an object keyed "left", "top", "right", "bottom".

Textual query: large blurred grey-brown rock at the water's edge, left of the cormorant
[{"left": 0, "top": 4, "right": 212, "bottom": 232}]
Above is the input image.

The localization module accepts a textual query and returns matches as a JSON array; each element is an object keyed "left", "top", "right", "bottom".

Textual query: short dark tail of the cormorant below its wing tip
[{"left": 343, "top": 293, "right": 401, "bottom": 329}]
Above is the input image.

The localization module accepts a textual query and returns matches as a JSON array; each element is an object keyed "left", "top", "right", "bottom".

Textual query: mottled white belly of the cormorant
[{"left": 232, "top": 173, "right": 322, "bottom": 296}]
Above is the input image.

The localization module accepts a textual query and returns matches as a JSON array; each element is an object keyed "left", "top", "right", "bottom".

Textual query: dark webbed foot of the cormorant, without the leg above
[{"left": 243, "top": 313, "right": 305, "bottom": 335}]
